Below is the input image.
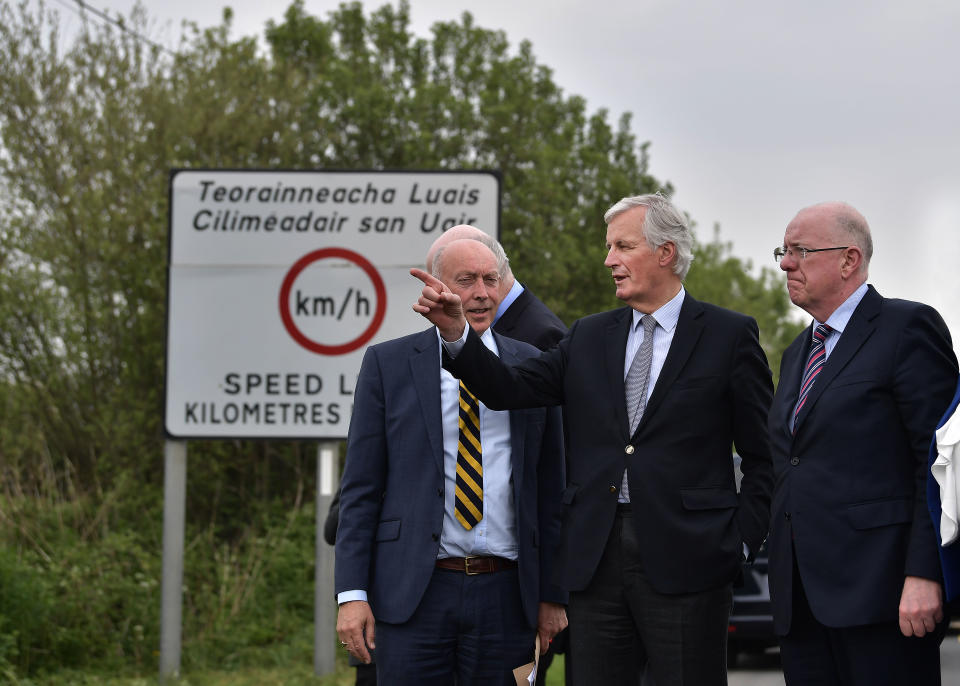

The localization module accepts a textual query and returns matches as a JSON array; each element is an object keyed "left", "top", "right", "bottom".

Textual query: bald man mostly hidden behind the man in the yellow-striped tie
[{"left": 427, "top": 224, "right": 567, "bottom": 350}]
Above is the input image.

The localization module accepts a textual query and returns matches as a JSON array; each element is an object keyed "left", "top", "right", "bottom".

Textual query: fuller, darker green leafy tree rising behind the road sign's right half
[{"left": 266, "top": 1, "right": 670, "bottom": 321}]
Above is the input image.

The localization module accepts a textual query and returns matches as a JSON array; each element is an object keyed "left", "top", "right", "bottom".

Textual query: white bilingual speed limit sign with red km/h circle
[{"left": 164, "top": 170, "right": 500, "bottom": 438}]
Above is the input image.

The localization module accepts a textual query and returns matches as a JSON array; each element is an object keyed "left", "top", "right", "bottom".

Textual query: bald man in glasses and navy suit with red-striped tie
[{"left": 769, "top": 202, "right": 957, "bottom": 686}]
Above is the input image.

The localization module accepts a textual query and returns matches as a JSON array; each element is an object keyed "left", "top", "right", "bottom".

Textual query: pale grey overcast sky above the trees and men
[{"left": 84, "top": 0, "right": 960, "bottom": 347}]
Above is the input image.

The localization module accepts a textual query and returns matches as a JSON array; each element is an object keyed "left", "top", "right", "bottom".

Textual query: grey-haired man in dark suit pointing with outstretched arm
[{"left": 413, "top": 195, "right": 773, "bottom": 686}]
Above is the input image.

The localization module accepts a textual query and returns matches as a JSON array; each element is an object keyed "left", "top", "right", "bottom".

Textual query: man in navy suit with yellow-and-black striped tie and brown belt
[{"left": 335, "top": 240, "right": 567, "bottom": 686}]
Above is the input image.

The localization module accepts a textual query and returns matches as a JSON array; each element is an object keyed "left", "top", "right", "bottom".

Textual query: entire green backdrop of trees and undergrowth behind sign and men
[{"left": 0, "top": 0, "right": 800, "bottom": 683}]
